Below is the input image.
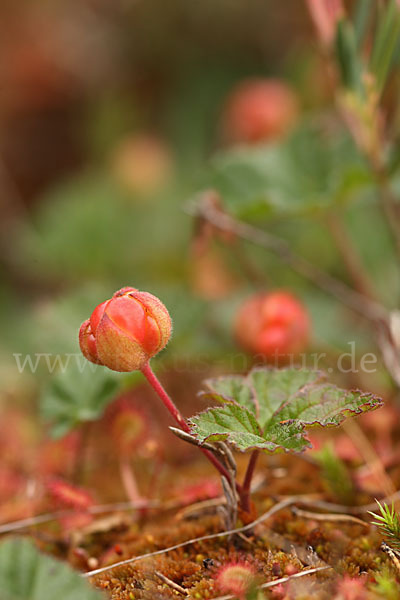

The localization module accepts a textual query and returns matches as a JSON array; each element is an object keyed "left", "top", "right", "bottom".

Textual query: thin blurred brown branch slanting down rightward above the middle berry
[{"left": 187, "top": 191, "right": 388, "bottom": 321}]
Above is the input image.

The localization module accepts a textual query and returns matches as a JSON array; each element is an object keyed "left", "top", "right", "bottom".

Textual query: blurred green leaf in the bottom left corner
[{"left": 0, "top": 538, "right": 105, "bottom": 600}]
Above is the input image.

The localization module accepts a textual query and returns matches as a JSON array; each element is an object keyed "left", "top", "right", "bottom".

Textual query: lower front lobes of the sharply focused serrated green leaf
[{"left": 190, "top": 402, "right": 310, "bottom": 452}]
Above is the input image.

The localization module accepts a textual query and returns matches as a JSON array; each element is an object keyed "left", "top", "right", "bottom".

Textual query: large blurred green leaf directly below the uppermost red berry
[{"left": 205, "top": 123, "right": 372, "bottom": 220}]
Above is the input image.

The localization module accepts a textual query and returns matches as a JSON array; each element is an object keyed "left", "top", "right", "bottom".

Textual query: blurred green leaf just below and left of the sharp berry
[{"left": 40, "top": 357, "right": 122, "bottom": 437}]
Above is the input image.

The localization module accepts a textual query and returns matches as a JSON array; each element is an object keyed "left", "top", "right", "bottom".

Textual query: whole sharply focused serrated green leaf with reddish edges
[{"left": 190, "top": 367, "right": 382, "bottom": 452}]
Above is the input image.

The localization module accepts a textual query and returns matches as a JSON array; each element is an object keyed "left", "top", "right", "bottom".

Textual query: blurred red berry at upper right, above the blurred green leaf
[{"left": 223, "top": 79, "right": 298, "bottom": 144}]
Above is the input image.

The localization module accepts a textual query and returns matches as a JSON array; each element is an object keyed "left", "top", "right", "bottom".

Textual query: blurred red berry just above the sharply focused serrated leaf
[{"left": 235, "top": 291, "right": 310, "bottom": 359}]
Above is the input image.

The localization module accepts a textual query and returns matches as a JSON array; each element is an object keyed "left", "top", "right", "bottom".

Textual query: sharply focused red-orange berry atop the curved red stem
[{"left": 79, "top": 287, "right": 172, "bottom": 372}]
